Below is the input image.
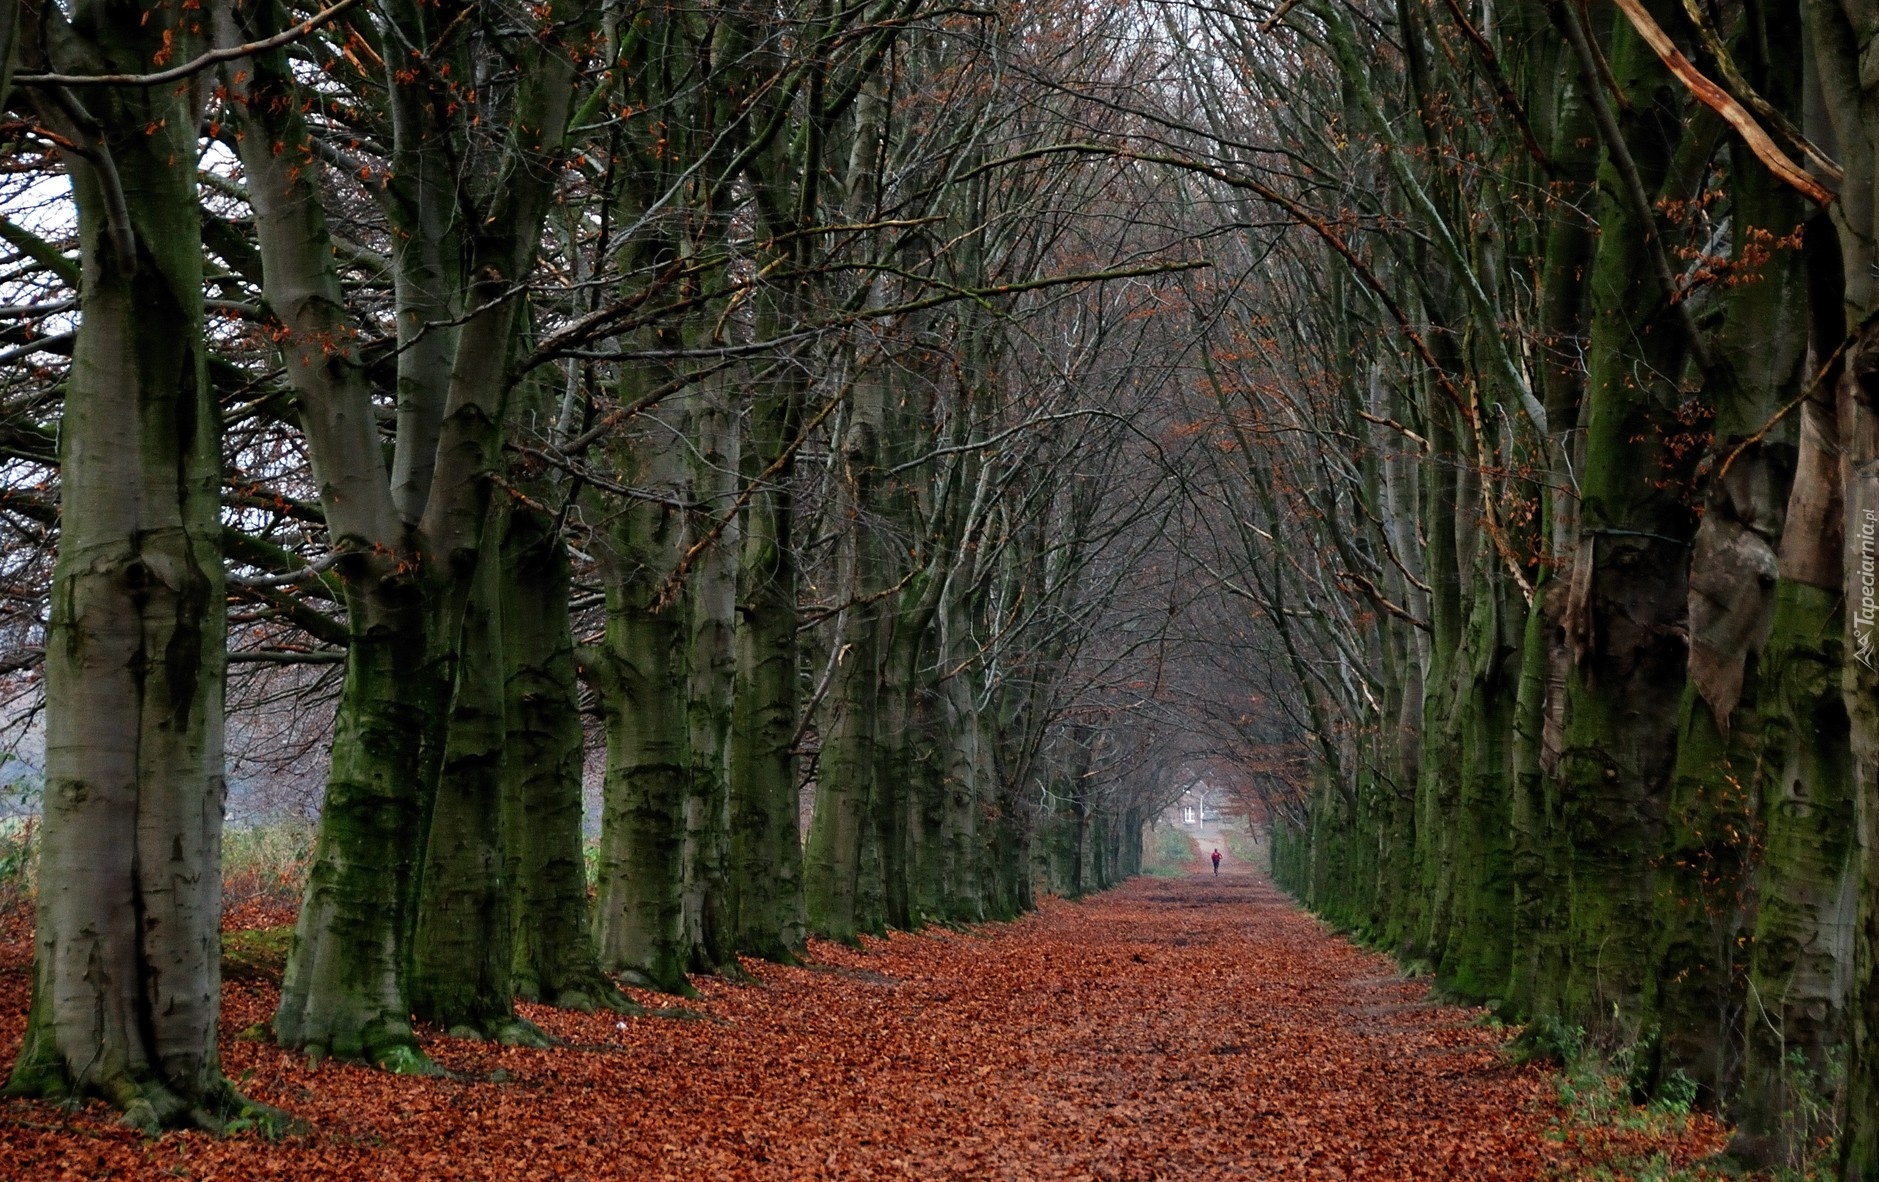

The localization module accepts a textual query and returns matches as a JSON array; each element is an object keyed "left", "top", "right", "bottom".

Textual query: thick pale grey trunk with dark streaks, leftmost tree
[{"left": 8, "top": 2, "right": 239, "bottom": 1131}]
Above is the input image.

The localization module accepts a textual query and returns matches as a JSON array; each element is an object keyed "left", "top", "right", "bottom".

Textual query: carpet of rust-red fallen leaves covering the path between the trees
[{"left": 0, "top": 859, "right": 1723, "bottom": 1182}]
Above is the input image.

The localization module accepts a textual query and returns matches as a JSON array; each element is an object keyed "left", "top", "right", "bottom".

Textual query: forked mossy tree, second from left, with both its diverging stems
[{"left": 228, "top": 2, "right": 592, "bottom": 1069}]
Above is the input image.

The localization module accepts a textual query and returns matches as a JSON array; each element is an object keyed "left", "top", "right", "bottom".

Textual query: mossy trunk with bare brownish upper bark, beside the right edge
[{"left": 1729, "top": 202, "right": 1858, "bottom": 1165}]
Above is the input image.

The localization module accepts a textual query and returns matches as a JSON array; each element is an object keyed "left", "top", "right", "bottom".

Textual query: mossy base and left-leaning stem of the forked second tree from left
[{"left": 216, "top": 4, "right": 435, "bottom": 1065}]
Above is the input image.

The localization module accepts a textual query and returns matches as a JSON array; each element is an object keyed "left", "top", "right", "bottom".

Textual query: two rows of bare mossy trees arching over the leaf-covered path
[{"left": 0, "top": 0, "right": 1879, "bottom": 1180}]
